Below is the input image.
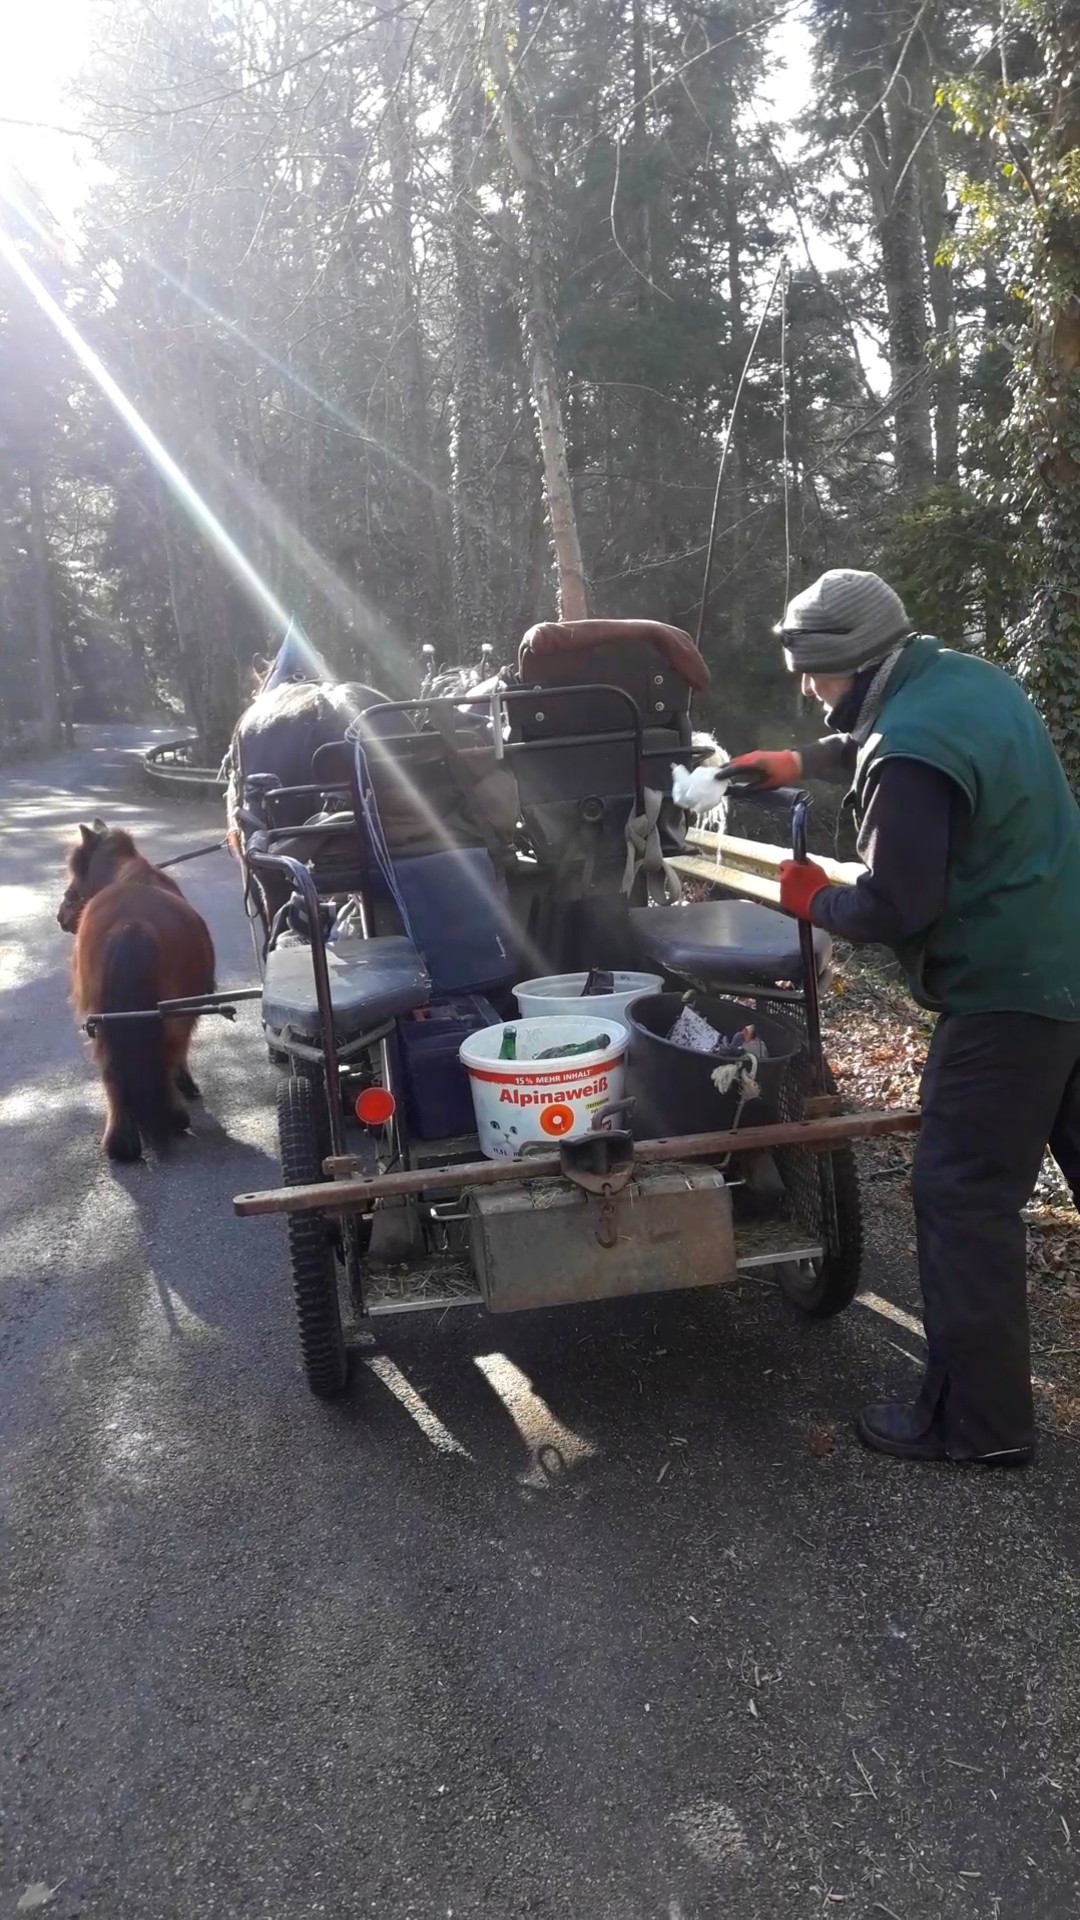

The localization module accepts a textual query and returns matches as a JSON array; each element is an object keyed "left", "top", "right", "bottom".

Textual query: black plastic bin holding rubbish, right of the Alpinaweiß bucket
[{"left": 625, "top": 993, "right": 803, "bottom": 1140}]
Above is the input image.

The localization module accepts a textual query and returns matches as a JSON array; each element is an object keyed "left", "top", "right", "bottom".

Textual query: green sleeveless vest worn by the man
[{"left": 851, "top": 639, "right": 1080, "bottom": 1020}]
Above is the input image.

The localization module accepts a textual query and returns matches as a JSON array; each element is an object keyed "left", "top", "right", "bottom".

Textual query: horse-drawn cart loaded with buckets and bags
[{"left": 222, "top": 622, "right": 915, "bottom": 1396}]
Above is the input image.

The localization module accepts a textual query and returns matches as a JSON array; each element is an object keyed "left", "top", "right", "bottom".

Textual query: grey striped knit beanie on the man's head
[{"left": 776, "top": 566, "right": 911, "bottom": 674}]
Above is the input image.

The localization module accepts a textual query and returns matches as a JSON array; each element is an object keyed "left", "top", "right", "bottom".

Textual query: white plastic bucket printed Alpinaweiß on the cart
[{"left": 459, "top": 1000, "right": 630, "bottom": 1160}]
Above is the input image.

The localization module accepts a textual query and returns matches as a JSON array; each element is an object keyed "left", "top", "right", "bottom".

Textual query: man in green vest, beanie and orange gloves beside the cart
[{"left": 736, "top": 568, "right": 1080, "bottom": 1465}]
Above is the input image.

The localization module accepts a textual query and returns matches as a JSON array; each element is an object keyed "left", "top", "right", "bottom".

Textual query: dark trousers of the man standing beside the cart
[{"left": 913, "top": 1014, "right": 1080, "bottom": 1459}]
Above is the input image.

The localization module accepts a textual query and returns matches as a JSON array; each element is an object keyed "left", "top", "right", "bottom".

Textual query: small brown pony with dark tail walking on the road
[{"left": 56, "top": 820, "right": 213, "bottom": 1160}]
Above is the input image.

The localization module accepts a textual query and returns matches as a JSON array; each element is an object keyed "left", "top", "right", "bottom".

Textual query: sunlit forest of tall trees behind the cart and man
[{"left": 0, "top": 0, "right": 1080, "bottom": 787}]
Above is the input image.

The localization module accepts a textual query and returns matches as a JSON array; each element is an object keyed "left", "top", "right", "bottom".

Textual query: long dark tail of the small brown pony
[{"left": 100, "top": 922, "right": 175, "bottom": 1152}]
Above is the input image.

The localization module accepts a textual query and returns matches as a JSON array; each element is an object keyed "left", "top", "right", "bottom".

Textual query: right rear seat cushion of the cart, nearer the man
[{"left": 630, "top": 900, "right": 832, "bottom": 987}]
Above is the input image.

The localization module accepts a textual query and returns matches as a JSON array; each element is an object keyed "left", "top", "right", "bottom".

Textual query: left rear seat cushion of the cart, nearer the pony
[{"left": 263, "top": 935, "right": 430, "bottom": 1044}]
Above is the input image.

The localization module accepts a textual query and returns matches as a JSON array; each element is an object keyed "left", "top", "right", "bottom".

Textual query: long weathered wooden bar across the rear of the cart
[{"left": 233, "top": 1108, "right": 919, "bottom": 1219}]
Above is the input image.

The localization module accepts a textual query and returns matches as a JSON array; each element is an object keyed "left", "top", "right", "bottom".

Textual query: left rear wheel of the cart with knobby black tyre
[{"left": 277, "top": 1079, "right": 348, "bottom": 1400}]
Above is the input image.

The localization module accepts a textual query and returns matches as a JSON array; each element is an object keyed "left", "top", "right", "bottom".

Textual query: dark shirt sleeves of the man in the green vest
[{"left": 801, "top": 710, "right": 967, "bottom": 947}]
